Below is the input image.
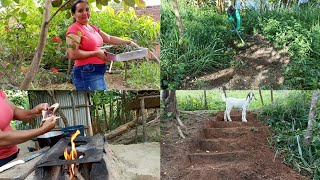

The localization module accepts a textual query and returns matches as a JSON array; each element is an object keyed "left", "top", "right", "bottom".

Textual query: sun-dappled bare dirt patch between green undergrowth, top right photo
[{"left": 182, "top": 35, "right": 289, "bottom": 89}]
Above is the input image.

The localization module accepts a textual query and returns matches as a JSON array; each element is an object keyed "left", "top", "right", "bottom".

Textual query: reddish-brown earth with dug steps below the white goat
[{"left": 161, "top": 111, "right": 307, "bottom": 180}]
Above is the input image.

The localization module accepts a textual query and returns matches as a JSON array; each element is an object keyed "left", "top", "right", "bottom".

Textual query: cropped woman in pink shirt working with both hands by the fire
[{"left": 0, "top": 89, "right": 57, "bottom": 167}]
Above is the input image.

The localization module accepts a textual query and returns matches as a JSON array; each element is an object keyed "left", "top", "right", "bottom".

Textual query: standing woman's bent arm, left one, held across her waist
[{"left": 66, "top": 34, "right": 108, "bottom": 61}]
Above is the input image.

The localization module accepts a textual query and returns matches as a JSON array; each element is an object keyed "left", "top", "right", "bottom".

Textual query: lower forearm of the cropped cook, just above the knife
[{"left": 0, "top": 116, "right": 58, "bottom": 146}]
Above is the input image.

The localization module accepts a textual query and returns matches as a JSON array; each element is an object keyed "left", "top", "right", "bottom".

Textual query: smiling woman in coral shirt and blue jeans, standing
[{"left": 66, "top": 0, "right": 139, "bottom": 90}]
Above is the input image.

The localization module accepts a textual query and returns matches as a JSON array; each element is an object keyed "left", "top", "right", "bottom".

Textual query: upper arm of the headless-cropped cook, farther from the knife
[{"left": 5, "top": 98, "right": 49, "bottom": 121}]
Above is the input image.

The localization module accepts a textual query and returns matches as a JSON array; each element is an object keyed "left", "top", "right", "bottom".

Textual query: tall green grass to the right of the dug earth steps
[{"left": 259, "top": 91, "right": 320, "bottom": 179}]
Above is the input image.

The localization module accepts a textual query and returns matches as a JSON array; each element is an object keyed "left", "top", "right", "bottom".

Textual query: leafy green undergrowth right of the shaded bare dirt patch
[{"left": 243, "top": 6, "right": 320, "bottom": 89}]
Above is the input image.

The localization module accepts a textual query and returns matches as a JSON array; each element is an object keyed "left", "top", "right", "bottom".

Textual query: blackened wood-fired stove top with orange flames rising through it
[{"left": 35, "top": 132, "right": 108, "bottom": 180}]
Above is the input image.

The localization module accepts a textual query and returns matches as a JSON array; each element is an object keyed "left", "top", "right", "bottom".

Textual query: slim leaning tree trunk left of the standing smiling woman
[{"left": 20, "top": 0, "right": 51, "bottom": 90}]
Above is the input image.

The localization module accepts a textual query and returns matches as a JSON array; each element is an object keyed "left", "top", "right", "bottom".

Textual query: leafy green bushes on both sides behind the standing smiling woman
[{"left": 0, "top": 0, "right": 160, "bottom": 88}]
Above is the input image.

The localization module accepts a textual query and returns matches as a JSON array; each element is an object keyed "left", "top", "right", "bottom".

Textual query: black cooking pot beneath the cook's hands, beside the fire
[{"left": 35, "top": 131, "right": 64, "bottom": 148}]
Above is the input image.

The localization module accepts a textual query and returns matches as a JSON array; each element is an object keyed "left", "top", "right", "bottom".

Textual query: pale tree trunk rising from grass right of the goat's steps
[{"left": 303, "top": 90, "right": 319, "bottom": 147}]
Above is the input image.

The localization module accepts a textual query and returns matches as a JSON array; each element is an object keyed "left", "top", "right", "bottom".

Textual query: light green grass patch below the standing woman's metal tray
[{"left": 127, "top": 61, "right": 160, "bottom": 89}]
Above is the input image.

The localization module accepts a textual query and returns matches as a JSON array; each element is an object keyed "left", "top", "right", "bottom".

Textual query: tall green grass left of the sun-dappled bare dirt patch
[{"left": 160, "top": 0, "right": 234, "bottom": 89}]
